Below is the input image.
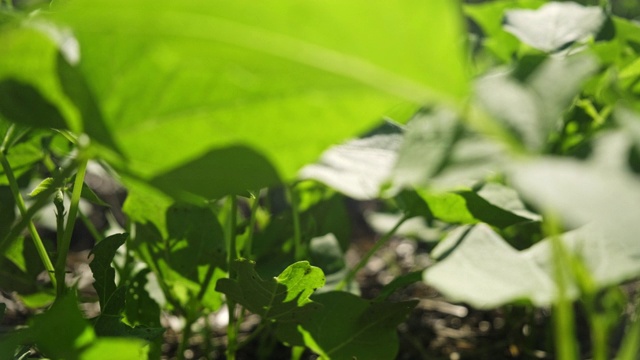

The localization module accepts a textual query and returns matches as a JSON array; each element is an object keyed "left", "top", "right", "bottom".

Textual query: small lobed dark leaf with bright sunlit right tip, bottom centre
[{"left": 216, "top": 260, "right": 325, "bottom": 322}]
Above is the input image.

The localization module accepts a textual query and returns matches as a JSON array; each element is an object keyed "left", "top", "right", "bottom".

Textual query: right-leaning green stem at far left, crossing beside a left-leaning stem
[{"left": 55, "top": 153, "right": 88, "bottom": 298}]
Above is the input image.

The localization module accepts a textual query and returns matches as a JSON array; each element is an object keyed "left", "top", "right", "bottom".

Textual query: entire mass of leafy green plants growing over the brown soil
[{"left": 0, "top": 0, "right": 640, "bottom": 360}]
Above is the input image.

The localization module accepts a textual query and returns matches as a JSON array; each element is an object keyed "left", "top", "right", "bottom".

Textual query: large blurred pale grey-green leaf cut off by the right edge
[{"left": 512, "top": 153, "right": 640, "bottom": 287}]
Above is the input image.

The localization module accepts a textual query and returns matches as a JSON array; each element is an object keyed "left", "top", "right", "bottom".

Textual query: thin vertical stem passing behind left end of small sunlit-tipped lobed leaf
[{"left": 226, "top": 195, "right": 238, "bottom": 360}]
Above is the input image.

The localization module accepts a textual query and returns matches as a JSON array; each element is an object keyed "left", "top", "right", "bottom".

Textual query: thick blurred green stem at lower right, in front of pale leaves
[{"left": 545, "top": 215, "right": 578, "bottom": 360}]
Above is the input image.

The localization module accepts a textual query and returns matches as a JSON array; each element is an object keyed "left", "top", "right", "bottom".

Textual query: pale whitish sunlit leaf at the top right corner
[{"left": 505, "top": 2, "right": 606, "bottom": 52}]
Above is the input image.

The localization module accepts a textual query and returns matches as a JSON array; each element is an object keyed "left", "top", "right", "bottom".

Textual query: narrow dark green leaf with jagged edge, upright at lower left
[{"left": 89, "top": 234, "right": 129, "bottom": 315}]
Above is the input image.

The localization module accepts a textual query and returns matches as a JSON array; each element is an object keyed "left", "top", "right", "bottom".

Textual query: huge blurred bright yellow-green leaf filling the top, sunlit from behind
[{"left": 51, "top": 0, "right": 467, "bottom": 197}]
